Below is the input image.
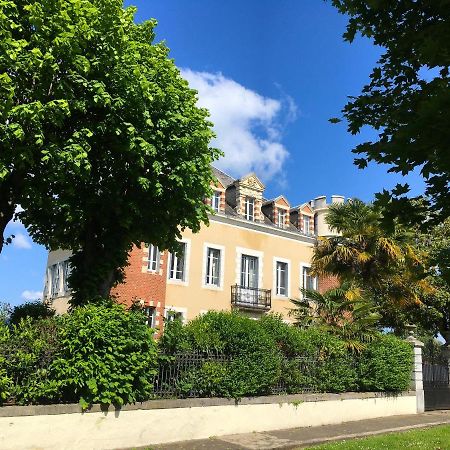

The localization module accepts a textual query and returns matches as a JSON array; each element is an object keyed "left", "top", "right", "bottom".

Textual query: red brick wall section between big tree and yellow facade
[{"left": 111, "top": 244, "right": 168, "bottom": 334}]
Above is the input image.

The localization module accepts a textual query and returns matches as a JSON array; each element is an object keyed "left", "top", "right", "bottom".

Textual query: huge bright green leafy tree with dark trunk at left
[{"left": 0, "top": 0, "right": 219, "bottom": 304}]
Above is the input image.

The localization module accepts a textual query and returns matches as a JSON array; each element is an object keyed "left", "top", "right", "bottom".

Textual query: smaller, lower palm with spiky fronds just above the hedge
[{"left": 289, "top": 282, "right": 380, "bottom": 352}]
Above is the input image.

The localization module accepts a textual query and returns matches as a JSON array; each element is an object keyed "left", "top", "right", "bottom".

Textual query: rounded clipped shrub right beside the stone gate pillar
[{"left": 358, "top": 334, "right": 413, "bottom": 392}]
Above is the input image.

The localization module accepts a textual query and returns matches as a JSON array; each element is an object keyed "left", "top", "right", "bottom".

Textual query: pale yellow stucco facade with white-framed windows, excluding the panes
[{"left": 165, "top": 215, "right": 314, "bottom": 320}]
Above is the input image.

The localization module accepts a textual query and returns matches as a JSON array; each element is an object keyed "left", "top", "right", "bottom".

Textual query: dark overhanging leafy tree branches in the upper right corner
[{"left": 332, "top": 0, "right": 450, "bottom": 220}]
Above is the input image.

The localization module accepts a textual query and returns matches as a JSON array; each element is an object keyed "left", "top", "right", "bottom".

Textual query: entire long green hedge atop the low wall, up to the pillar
[{"left": 0, "top": 304, "right": 412, "bottom": 407}]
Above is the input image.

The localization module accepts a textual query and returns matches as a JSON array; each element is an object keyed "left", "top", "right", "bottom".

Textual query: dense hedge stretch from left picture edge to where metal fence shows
[{"left": 0, "top": 303, "right": 157, "bottom": 408}]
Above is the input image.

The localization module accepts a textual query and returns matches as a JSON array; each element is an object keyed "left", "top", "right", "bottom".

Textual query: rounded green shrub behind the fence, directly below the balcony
[{"left": 161, "top": 311, "right": 281, "bottom": 398}]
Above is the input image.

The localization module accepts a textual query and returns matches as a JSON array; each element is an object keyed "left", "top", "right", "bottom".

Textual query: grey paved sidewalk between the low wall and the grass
[{"left": 151, "top": 411, "right": 450, "bottom": 450}]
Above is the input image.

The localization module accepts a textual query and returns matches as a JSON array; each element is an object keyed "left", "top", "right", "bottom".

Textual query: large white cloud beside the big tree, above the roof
[{"left": 181, "top": 69, "right": 297, "bottom": 180}]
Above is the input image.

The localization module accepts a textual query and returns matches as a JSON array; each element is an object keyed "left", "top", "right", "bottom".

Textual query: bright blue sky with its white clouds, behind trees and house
[{"left": 0, "top": 0, "right": 423, "bottom": 304}]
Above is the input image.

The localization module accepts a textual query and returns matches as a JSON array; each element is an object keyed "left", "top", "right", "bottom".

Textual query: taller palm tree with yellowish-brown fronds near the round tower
[{"left": 312, "top": 199, "right": 429, "bottom": 326}]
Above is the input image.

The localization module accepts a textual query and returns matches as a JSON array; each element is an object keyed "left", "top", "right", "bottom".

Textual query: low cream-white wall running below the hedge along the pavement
[{"left": 0, "top": 394, "right": 416, "bottom": 450}]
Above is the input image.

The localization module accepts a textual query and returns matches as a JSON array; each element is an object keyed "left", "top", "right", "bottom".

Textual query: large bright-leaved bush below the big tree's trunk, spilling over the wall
[{"left": 52, "top": 304, "right": 157, "bottom": 409}]
